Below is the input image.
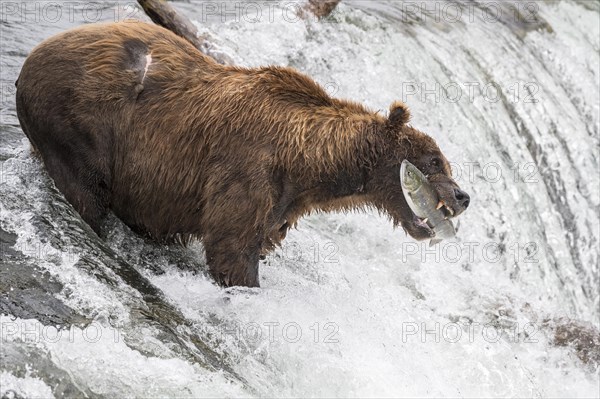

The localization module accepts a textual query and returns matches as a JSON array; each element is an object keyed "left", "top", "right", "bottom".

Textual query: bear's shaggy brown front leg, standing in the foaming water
[{"left": 201, "top": 167, "right": 273, "bottom": 287}]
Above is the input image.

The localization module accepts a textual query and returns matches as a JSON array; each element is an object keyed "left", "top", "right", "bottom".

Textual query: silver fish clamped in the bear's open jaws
[{"left": 400, "top": 160, "right": 457, "bottom": 246}]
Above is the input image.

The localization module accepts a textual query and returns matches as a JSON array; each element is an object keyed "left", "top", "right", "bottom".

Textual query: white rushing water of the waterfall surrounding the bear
[{"left": 0, "top": 1, "right": 600, "bottom": 397}]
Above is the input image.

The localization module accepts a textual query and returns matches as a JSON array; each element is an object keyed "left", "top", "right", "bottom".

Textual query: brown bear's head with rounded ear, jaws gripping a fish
[{"left": 369, "top": 102, "right": 470, "bottom": 240}]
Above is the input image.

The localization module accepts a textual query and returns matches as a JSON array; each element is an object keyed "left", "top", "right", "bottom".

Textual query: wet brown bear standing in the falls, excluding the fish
[{"left": 16, "top": 22, "right": 469, "bottom": 287}]
